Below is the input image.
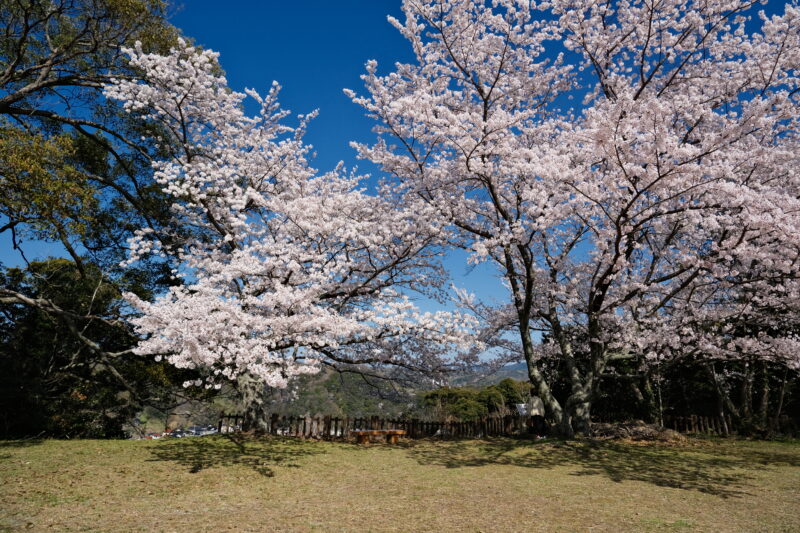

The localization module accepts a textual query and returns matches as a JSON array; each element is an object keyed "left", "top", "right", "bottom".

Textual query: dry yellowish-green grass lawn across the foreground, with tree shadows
[{"left": 0, "top": 436, "right": 800, "bottom": 532}]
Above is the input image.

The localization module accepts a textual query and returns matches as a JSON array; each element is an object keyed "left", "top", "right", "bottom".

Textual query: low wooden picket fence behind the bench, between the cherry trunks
[{"left": 219, "top": 414, "right": 528, "bottom": 439}]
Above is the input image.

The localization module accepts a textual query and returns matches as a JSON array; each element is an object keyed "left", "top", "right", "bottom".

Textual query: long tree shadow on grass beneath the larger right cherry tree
[{"left": 405, "top": 439, "right": 800, "bottom": 498}]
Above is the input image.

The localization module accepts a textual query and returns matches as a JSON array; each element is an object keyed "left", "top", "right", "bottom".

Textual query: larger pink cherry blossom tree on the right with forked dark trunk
[{"left": 348, "top": 0, "right": 800, "bottom": 434}]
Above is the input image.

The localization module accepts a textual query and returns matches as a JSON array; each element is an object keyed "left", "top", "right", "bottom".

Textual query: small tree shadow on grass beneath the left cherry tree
[{"left": 149, "top": 434, "right": 323, "bottom": 477}]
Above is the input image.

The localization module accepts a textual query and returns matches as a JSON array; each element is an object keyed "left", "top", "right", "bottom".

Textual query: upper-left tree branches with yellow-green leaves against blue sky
[{"left": 0, "top": 0, "right": 184, "bottom": 272}]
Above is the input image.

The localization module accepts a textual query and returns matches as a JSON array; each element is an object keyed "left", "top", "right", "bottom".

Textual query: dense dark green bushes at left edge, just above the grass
[{"left": 0, "top": 259, "right": 203, "bottom": 438}]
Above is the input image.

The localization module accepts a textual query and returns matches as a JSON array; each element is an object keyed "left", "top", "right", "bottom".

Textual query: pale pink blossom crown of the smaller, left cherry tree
[{"left": 106, "top": 42, "right": 470, "bottom": 426}]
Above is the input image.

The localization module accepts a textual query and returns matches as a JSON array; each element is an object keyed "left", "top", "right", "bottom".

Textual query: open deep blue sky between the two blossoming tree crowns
[{"left": 171, "top": 0, "right": 411, "bottom": 172}]
